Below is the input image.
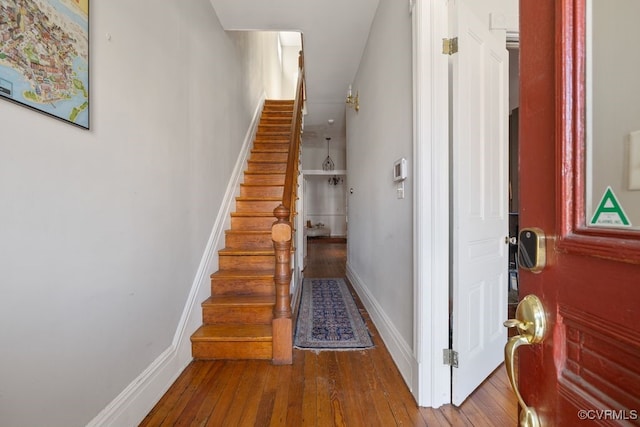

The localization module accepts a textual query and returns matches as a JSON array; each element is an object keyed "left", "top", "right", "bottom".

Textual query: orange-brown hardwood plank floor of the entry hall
[{"left": 140, "top": 241, "right": 517, "bottom": 427}]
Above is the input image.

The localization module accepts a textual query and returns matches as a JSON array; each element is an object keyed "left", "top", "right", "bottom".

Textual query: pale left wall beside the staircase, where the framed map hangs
[{"left": 0, "top": 0, "right": 272, "bottom": 427}]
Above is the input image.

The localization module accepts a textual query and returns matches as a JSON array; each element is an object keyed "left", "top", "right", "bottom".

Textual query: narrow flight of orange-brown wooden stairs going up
[{"left": 191, "top": 100, "right": 294, "bottom": 359}]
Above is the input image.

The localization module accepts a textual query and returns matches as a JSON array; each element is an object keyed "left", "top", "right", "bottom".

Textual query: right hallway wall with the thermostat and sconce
[{"left": 347, "top": 0, "right": 414, "bottom": 349}]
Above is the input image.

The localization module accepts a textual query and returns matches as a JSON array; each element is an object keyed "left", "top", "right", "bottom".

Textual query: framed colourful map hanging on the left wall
[{"left": 0, "top": 0, "right": 89, "bottom": 129}]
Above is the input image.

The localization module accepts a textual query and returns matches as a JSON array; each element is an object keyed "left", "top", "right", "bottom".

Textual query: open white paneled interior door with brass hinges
[{"left": 451, "top": 1, "right": 509, "bottom": 405}]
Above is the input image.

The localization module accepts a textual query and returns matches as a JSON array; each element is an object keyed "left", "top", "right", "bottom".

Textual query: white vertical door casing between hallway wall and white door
[{"left": 412, "top": 0, "right": 451, "bottom": 408}]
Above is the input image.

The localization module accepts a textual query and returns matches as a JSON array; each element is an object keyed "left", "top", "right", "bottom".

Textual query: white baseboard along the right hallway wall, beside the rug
[{"left": 346, "top": 262, "right": 418, "bottom": 391}]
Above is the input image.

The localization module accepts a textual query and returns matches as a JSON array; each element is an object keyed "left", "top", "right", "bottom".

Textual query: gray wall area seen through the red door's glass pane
[{"left": 587, "top": 0, "right": 640, "bottom": 228}]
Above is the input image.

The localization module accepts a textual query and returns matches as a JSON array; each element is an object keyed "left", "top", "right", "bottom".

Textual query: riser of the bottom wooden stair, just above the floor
[{"left": 191, "top": 341, "right": 273, "bottom": 360}]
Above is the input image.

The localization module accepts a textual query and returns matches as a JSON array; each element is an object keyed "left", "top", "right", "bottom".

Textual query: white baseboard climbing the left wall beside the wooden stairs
[{"left": 87, "top": 96, "right": 265, "bottom": 427}]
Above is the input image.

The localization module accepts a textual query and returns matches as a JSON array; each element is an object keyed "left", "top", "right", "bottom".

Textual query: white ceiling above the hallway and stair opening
[{"left": 210, "top": 0, "right": 379, "bottom": 144}]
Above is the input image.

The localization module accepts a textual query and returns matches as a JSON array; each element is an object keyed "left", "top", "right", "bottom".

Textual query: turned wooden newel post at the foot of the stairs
[{"left": 271, "top": 205, "right": 293, "bottom": 365}]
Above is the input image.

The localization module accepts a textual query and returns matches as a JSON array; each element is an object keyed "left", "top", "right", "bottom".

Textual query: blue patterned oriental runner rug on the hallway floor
[{"left": 294, "top": 278, "right": 373, "bottom": 350}]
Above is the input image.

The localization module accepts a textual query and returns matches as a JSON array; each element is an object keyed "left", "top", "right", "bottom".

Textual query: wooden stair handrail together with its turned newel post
[{"left": 271, "top": 51, "right": 304, "bottom": 365}]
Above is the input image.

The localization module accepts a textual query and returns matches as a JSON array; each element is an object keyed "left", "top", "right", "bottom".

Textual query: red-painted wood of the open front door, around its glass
[{"left": 516, "top": 0, "right": 640, "bottom": 426}]
